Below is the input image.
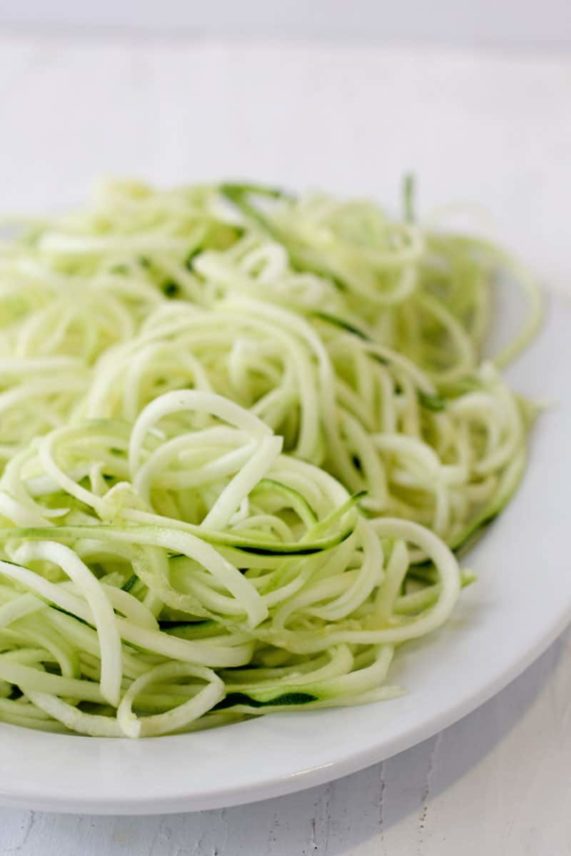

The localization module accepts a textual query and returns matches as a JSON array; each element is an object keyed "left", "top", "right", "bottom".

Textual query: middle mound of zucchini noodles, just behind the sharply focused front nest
[{"left": 85, "top": 298, "right": 526, "bottom": 547}]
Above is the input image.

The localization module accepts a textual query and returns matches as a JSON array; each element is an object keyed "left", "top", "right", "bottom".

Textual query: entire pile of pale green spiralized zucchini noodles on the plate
[{"left": 0, "top": 182, "right": 540, "bottom": 737}]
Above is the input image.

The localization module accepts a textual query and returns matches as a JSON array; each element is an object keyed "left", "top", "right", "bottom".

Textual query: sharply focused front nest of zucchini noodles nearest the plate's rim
[{"left": 0, "top": 390, "right": 460, "bottom": 737}]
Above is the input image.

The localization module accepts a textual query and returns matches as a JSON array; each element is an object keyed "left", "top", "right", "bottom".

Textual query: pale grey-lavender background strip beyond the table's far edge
[{"left": 0, "top": 0, "right": 571, "bottom": 50}]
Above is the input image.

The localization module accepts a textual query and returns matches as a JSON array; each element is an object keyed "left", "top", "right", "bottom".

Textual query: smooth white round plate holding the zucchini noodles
[{"left": 0, "top": 290, "right": 571, "bottom": 814}]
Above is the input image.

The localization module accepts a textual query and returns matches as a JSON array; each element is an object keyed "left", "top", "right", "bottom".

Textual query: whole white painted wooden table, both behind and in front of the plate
[{"left": 0, "top": 28, "right": 571, "bottom": 856}]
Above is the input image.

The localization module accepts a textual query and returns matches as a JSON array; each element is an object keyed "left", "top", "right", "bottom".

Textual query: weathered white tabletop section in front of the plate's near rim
[{"left": 0, "top": 631, "right": 571, "bottom": 856}]
